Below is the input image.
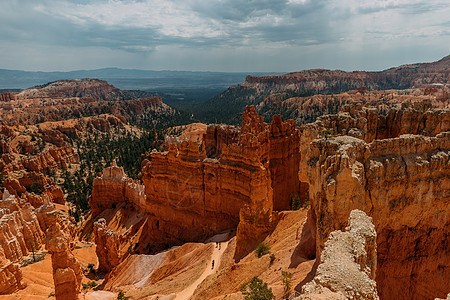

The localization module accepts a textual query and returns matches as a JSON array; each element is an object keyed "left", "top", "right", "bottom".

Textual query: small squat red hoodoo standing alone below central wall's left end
[{"left": 94, "top": 219, "right": 122, "bottom": 272}]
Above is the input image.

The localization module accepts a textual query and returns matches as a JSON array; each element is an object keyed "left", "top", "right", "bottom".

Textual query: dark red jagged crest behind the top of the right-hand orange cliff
[{"left": 299, "top": 101, "right": 450, "bottom": 183}]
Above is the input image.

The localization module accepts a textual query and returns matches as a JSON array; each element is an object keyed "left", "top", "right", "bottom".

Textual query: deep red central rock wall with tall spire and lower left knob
[{"left": 90, "top": 106, "right": 300, "bottom": 256}]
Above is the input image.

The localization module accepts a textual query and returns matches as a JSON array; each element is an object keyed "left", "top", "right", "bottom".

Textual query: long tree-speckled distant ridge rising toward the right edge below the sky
[{"left": 194, "top": 56, "right": 450, "bottom": 124}]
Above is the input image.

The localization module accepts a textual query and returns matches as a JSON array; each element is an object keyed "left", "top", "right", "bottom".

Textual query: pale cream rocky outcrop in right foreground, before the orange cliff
[{"left": 296, "top": 210, "right": 379, "bottom": 300}]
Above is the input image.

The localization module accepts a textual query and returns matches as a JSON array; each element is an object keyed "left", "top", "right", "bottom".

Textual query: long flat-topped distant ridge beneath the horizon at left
[{"left": 0, "top": 79, "right": 188, "bottom": 128}]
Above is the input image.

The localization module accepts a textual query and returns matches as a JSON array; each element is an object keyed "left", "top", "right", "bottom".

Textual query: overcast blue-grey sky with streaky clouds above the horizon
[{"left": 0, "top": 0, "right": 450, "bottom": 72}]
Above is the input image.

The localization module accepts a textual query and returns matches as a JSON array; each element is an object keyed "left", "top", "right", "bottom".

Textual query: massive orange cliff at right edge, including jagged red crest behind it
[{"left": 300, "top": 106, "right": 450, "bottom": 299}]
